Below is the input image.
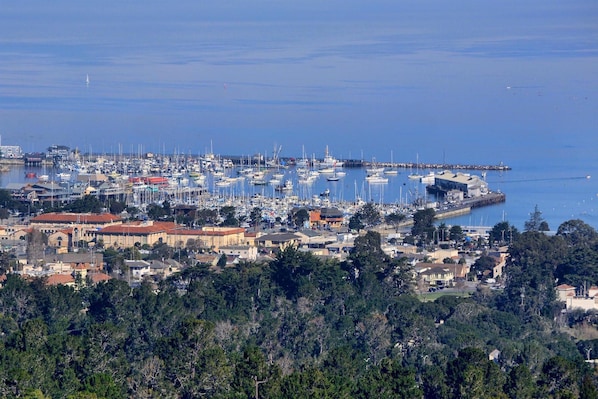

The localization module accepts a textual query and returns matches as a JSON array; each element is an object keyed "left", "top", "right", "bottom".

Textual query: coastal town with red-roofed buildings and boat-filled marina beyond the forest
[{"left": 0, "top": 145, "right": 508, "bottom": 288}]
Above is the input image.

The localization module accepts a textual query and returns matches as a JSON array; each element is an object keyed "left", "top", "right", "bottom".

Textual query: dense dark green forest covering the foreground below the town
[{"left": 0, "top": 220, "right": 598, "bottom": 399}]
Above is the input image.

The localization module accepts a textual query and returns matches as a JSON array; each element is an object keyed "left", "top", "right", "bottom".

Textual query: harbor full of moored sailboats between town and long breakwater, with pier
[{"left": 0, "top": 151, "right": 510, "bottom": 230}]
